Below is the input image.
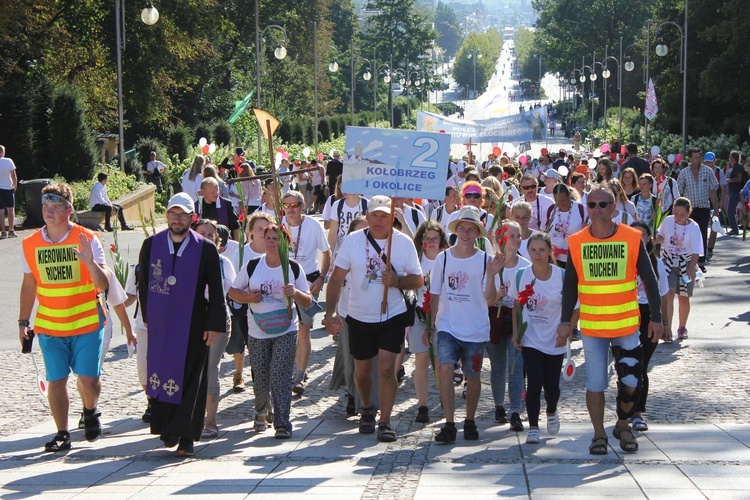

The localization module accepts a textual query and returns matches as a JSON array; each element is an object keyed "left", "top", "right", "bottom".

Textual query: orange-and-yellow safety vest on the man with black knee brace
[{"left": 568, "top": 224, "right": 641, "bottom": 338}]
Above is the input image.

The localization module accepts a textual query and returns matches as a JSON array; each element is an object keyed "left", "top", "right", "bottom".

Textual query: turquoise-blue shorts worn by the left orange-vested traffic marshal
[{"left": 38, "top": 324, "right": 104, "bottom": 382}]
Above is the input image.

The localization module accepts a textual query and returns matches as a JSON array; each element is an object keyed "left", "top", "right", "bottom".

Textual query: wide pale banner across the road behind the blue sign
[{"left": 417, "top": 110, "right": 547, "bottom": 144}]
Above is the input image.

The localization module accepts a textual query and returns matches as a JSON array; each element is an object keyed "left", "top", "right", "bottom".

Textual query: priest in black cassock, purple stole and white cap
[{"left": 138, "top": 193, "right": 227, "bottom": 456}]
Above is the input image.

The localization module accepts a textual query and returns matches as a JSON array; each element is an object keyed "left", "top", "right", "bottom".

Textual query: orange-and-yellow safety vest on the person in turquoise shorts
[{"left": 23, "top": 225, "right": 102, "bottom": 337}]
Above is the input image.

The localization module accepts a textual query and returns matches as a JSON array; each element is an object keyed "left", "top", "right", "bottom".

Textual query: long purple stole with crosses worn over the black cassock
[{"left": 146, "top": 230, "right": 203, "bottom": 404}]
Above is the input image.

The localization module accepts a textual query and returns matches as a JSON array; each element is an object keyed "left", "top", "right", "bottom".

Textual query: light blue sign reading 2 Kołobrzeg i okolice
[{"left": 341, "top": 127, "right": 451, "bottom": 200}]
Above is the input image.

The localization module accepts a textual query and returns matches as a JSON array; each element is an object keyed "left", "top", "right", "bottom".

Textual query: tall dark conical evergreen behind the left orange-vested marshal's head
[{"left": 48, "top": 86, "right": 97, "bottom": 181}]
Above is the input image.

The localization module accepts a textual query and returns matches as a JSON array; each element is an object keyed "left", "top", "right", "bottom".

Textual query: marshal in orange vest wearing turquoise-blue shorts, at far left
[{"left": 18, "top": 183, "right": 109, "bottom": 452}]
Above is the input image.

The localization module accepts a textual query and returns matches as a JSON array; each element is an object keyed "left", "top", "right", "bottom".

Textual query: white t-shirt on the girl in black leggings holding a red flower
[{"left": 509, "top": 265, "right": 565, "bottom": 355}]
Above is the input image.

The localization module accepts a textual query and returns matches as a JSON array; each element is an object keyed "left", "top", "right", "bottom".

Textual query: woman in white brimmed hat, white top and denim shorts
[{"left": 424, "top": 206, "right": 505, "bottom": 443}]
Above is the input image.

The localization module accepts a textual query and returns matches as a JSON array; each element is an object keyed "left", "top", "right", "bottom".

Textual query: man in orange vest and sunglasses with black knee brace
[{"left": 557, "top": 184, "right": 663, "bottom": 455}]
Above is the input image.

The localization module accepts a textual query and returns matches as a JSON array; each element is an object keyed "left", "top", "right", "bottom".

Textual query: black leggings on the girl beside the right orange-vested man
[{"left": 521, "top": 347, "right": 565, "bottom": 427}]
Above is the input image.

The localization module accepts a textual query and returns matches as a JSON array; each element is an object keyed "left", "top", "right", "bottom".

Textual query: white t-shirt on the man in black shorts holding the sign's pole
[{"left": 336, "top": 229, "right": 422, "bottom": 323}]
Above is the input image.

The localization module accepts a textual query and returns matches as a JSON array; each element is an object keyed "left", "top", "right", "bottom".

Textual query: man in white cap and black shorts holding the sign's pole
[{"left": 326, "top": 195, "right": 423, "bottom": 442}]
